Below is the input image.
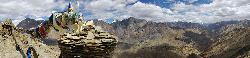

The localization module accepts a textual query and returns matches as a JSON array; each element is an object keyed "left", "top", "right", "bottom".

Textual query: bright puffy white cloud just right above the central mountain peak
[{"left": 128, "top": 2, "right": 169, "bottom": 19}]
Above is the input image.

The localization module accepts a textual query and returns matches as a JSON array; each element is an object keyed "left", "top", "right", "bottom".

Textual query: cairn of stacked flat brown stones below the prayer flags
[{"left": 58, "top": 31, "right": 117, "bottom": 58}]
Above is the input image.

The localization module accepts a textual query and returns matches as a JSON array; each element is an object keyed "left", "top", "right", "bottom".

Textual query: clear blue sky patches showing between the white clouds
[{"left": 83, "top": 0, "right": 216, "bottom": 22}]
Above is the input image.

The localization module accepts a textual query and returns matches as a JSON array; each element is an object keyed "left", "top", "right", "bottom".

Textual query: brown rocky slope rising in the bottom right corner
[{"left": 203, "top": 24, "right": 250, "bottom": 58}]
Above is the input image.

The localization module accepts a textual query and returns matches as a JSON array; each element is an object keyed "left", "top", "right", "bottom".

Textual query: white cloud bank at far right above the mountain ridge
[{"left": 171, "top": 0, "right": 250, "bottom": 23}]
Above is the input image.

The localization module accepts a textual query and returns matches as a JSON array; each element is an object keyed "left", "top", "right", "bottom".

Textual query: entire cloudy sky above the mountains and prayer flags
[{"left": 0, "top": 0, "right": 250, "bottom": 23}]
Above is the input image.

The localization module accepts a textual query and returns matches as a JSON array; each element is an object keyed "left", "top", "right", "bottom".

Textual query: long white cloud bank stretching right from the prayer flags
[{"left": 85, "top": 0, "right": 171, "bottom": 20}]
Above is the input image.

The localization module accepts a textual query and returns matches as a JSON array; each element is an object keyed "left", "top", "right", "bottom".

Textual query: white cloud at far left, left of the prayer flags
[{"left": 0, "top": 0, "right": 65, "bottom": 23}]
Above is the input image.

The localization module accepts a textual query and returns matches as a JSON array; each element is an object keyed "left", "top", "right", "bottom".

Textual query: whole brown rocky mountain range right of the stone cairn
[{"left": 14, "top": 17, "right": 250, "bottom": 58}]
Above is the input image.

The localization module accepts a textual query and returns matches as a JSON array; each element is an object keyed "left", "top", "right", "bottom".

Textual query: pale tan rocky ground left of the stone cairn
[{"left": 0, "top": 31, "right": 60, "bottom": 58}]
